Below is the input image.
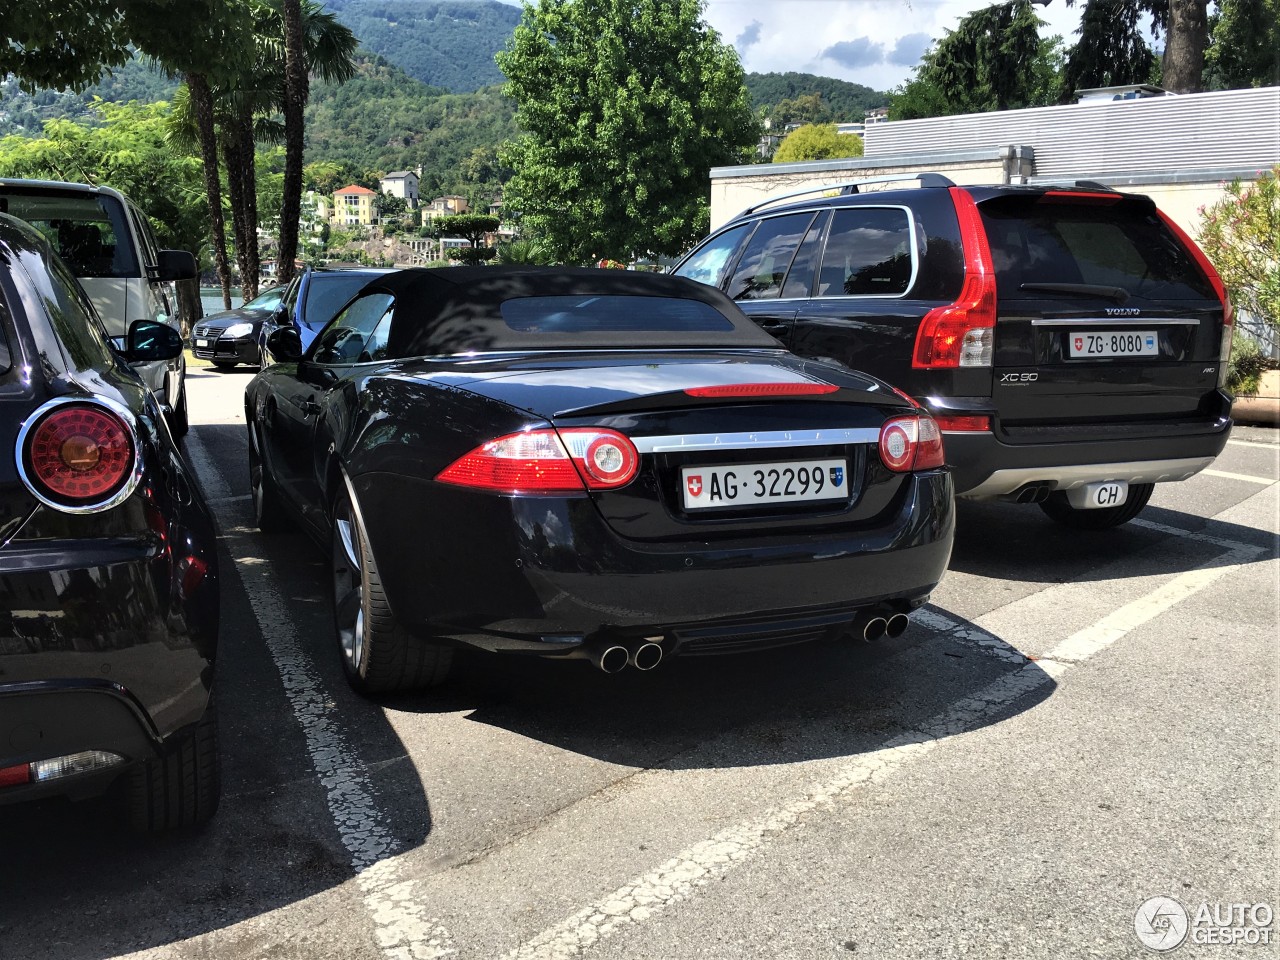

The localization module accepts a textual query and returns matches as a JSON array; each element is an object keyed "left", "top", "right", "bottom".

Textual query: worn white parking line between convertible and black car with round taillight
[{"left": 184, "top": 428, "right": 456, "bottom": 960}]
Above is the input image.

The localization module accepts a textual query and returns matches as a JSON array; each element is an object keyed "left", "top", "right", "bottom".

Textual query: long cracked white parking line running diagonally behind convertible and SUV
[{"left": 506, "top": 514, "right": 1266, "bottom": 960}]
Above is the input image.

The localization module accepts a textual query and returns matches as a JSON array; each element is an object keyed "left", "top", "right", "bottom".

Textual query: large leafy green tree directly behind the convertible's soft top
[{"left": 498, "top": 0, "right": 759, "bottom": 262}]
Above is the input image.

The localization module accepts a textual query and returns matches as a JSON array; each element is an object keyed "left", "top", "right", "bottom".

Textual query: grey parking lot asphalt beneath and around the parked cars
[{"left": 0, "top": 370, "right": 1280, "bottom": 960}]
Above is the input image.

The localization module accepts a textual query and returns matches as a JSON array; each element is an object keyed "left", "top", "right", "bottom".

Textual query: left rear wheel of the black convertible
[{"left": 330, "top": 489, "right": 453, "bottom": 694}]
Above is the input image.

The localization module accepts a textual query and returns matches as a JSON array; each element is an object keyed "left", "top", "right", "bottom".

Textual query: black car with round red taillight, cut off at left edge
[{"left": 0, "top": 215, "right": 219, "bottom": 829}]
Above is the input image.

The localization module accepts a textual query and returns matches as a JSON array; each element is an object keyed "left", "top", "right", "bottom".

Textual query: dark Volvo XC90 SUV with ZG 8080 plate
[{"left": 675, "top": 174, "right": 1231, "bottom": 530}]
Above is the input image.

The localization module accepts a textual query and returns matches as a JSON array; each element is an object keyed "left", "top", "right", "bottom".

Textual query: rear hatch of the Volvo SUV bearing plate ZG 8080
[{"left": 974, "top": 189, "right": 1231, "bottom": 443}]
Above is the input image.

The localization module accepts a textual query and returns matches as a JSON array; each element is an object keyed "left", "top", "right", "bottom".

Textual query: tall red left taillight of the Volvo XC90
[{"left": 911, "top": 187, "right": 996, "bottom": 370}]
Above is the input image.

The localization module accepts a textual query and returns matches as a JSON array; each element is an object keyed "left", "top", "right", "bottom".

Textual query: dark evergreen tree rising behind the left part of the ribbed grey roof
[{"left": 890, "top": 0, "right": 1060, "bottom": 120}]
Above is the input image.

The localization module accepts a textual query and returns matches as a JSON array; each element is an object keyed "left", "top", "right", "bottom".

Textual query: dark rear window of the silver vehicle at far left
[{"left": 0, "top": 187, "right": 142, "bottom": 278}]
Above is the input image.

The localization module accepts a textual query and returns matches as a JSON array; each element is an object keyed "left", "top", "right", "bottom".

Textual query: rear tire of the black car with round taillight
[{"left": 127, "top": 698, "right": 221, "bottom": 833}]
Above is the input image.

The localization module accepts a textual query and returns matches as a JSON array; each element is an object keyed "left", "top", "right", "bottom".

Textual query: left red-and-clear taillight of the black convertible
[{"left": 435, "top": 428, "right": 640, "bottom": 494}]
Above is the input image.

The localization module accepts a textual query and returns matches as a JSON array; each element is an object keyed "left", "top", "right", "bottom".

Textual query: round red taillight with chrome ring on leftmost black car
[{"left": 17, "top": 398, "right": 140, "bottom": 513}]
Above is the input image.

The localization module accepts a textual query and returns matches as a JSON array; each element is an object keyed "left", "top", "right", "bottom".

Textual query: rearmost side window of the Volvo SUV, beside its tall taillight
[{"left": 818, "top": 207, "right": 915, "bottom": 297}]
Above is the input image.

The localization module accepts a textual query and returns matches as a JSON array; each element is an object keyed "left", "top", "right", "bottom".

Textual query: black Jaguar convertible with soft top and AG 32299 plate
[{"left": 246, "top": 268, "right": 954, "bottom": 692}]
